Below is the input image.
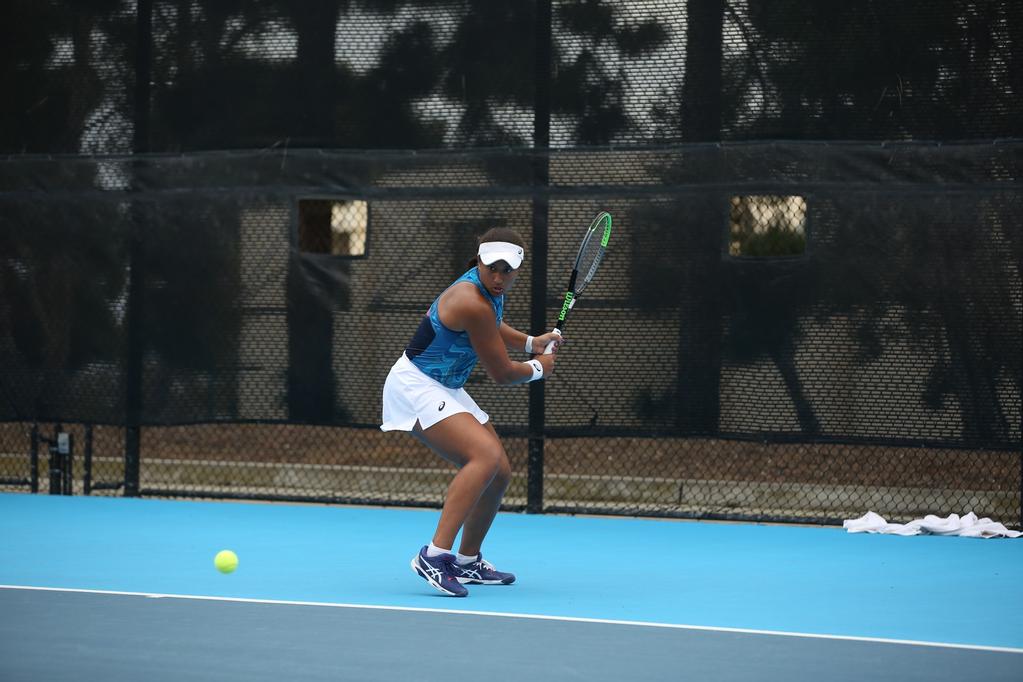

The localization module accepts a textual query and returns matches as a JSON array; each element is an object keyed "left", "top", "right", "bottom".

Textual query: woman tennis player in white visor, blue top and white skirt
[{"left": 381, "top": 228, "right": 562, "bottom": 597}]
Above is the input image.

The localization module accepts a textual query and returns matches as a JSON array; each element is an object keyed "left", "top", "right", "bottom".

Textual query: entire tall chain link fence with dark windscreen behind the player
[{"left": 0, "top": 0, "right": 1023, "bottom": 525}]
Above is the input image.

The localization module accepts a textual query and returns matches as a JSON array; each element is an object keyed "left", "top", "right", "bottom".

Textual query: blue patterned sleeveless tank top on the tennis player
[{"left": 405, "top": 268, "right": 504, "bottom": 389}]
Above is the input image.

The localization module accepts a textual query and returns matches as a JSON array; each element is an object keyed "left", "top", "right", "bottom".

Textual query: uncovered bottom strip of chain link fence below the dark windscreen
[{"left": 0, "top": 423, "right": 1020, "bottom": 528}]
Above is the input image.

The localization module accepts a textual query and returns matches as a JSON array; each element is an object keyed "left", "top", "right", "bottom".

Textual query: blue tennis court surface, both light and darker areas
[{"left": 0, "top": 494, "right": 1023, "bottom": 682}]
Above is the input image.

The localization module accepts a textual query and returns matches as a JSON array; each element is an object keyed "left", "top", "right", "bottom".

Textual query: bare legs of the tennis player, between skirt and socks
[{"left": 412, "top": 412, "right": 512, "bottom": 554}]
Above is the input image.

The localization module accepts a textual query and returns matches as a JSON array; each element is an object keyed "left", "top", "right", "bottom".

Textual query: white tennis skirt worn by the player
[{"left": 381, "top": 353, "right": 490, "bottom": 431}]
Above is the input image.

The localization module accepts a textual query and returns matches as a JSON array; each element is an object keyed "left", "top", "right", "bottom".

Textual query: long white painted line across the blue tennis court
[{"left": 0, "top": 585, "right": 1023, "bottom": 653}]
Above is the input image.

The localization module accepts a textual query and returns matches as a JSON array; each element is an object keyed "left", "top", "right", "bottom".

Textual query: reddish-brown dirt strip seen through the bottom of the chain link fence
[{"left": 0, "top": 423, "right": 1021, "bottom": 492}]
